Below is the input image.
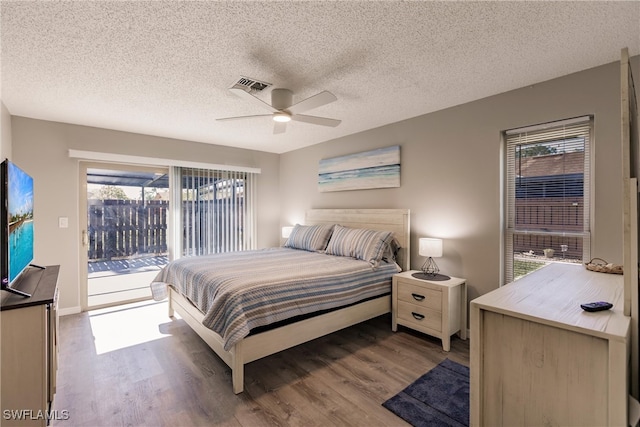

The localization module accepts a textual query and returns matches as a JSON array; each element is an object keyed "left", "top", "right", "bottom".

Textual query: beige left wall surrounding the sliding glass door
[{"left": 12, "top": 116, "right": 280, "bottom": 313}]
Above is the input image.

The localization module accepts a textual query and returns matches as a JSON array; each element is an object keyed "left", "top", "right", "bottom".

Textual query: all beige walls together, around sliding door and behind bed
[{"left": 2, "top": 57, "right": 640, "bottom": 309}]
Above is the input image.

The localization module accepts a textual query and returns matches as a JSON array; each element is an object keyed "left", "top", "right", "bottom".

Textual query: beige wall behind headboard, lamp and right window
[{"left": 280, "top": 57, "right": 640, "bottom": 300}]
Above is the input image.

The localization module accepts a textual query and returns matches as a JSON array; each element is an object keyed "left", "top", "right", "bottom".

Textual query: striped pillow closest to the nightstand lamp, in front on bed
[{"left": 326, "top": 225, "right": 393, "bottom": 267}]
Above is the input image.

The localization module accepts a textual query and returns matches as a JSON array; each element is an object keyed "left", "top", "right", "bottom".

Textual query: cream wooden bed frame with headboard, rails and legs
[{"left": 169, "top": 209, "right": 410, "bottom": 394}]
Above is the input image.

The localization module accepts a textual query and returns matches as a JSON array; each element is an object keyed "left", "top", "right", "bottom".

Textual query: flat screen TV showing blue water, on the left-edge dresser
[{"left": 0, "top": 159, "right": 34, "bottom": 297}]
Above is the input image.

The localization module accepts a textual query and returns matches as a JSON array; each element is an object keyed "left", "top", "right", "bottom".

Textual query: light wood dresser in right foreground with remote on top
[{"left": 470, "top": 263, "right": 631, "bottom": 426}]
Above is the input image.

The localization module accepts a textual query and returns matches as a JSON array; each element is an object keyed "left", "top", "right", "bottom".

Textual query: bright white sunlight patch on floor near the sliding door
[{"left": 89, "top": 301, "right": 179, "bottom": 354}]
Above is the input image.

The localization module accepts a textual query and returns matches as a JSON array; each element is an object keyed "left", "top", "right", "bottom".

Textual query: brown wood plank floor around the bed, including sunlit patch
[{"left": 51, "top": 303, "right": 469, "bottom": 427}]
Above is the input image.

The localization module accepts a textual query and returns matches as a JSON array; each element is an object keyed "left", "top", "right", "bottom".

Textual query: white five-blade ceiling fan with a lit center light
[{"left": 217, "top": 87, "right": 341, "bottom": 133}]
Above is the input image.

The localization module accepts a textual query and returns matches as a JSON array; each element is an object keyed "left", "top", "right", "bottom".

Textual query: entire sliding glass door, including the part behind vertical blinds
[{"left": 80, "top": 162, "right": 258, "bottom": 310}]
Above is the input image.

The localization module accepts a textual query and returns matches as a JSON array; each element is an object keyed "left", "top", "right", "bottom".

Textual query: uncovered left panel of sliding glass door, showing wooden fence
[{"left": 81, "top": 163, "right": 169, "bottom": 310}]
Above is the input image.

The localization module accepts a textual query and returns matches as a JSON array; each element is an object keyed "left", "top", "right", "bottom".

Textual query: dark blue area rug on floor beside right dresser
[{"left": 382, "top": 359, "right": 469, "bottom": 427}]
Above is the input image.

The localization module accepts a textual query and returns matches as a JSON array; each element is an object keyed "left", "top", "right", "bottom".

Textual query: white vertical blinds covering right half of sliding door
[{"left": 174, "top": 167, "right": 257, "bottom": 256}]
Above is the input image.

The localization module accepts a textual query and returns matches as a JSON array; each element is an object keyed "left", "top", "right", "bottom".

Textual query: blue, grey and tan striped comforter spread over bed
[{"left": 154, "top": 248, "right": 400, "bottom": 350}]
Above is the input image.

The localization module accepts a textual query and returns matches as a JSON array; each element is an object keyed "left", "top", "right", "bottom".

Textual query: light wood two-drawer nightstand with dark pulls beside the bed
[{"left": 391, "top": 270, "right": 467, "bottom": 351}]
